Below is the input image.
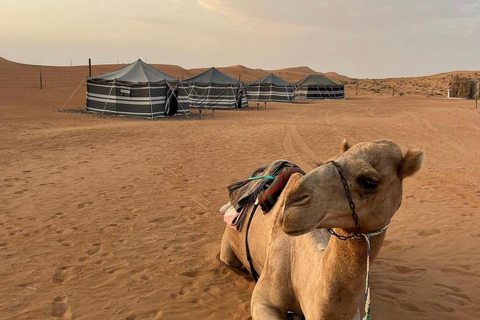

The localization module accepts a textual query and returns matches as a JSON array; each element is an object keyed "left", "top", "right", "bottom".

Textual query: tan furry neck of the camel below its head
[{"left": 320, "top": 229, "right": 385, "bottom": 319}]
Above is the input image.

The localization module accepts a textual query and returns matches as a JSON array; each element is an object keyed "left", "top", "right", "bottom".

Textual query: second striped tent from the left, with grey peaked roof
[{"left": 182, "top": 67, "right": 248, "bottom": 109}]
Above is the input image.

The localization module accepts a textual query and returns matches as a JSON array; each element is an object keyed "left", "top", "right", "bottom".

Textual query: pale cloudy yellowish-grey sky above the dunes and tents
[{"left": 0, "top": 0, "right": 480, "bottom": 78}]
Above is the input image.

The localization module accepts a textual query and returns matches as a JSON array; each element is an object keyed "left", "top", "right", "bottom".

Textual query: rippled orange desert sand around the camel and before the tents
[{"left": 0, "top": 88, "right": 480, "bottom": 320}]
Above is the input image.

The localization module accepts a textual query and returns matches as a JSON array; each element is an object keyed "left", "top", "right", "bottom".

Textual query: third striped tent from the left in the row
[{"left": 247, "top": 73, "right": 295, "bottom": 103}]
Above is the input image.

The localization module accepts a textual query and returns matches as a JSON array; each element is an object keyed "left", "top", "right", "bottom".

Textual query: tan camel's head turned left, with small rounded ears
[{"left": 281, "top": 140, "right": 423, "bottom": 235}]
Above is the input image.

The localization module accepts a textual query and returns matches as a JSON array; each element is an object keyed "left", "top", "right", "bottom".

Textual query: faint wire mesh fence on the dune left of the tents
[{"left": 0, "top": 65, "right": 122, "bottom": 89}]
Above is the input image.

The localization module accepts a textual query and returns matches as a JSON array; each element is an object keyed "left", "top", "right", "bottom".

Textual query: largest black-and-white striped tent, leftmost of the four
[{"left": 86, "top": 59, "right": 189, "bottom": 119}]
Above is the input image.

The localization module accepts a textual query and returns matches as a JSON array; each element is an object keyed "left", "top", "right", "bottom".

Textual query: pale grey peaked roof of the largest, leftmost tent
[{"left": 87, "top": 59, "right": 178, "bottom": 83}]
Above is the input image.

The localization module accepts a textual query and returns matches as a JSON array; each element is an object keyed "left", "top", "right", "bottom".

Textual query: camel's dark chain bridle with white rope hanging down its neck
[{"left": 325, "top": 160, "right": 390, "bottom": 320}]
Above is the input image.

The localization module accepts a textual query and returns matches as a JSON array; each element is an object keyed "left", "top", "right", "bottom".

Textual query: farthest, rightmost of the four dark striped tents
[{"left": 295, "top": 74, "right": 345, "bottom": 100}]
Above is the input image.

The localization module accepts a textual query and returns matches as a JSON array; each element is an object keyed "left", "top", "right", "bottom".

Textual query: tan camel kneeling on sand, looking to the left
[{"left": 220, "top": 140, "right": 423, "bottom": 320}]
